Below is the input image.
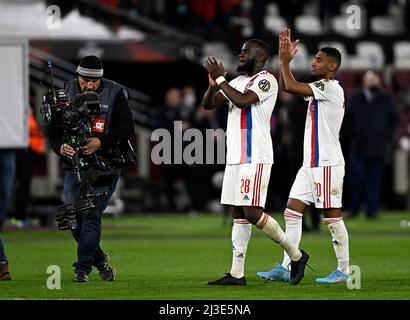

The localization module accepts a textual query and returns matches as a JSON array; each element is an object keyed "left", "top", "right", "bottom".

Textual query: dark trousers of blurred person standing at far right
[{"left": 346, "top": 154, "right": 384, "bottom": 218}]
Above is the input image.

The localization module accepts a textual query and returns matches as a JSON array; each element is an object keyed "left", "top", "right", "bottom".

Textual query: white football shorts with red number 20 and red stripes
[{"left": 289, "top": 165, "right": 345, "bottom": 209}]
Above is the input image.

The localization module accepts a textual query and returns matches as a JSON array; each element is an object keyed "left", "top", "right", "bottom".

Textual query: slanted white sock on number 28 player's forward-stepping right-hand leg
[{"left": 256, "top": 213, "right": 302, "bottom": 261}]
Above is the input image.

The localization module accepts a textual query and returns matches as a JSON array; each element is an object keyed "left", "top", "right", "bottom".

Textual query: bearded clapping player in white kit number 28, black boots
[{"left": 202, "top": 39, "right": 309, "bottom": 285}]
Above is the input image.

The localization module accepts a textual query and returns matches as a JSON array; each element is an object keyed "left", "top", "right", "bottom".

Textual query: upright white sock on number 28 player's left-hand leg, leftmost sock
[{"left": 229, "top": 219, "right": 252, "bottom": 278}]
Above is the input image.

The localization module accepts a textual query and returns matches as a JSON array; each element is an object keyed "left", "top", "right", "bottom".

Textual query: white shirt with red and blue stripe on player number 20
[{"left": 303, "top": 79, "right": 345, "bottom": 168}]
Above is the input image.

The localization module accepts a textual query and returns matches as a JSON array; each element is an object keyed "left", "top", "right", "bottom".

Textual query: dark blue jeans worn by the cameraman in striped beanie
[{"left": 64, "top": 170, "right": 120, "bottom": 274}]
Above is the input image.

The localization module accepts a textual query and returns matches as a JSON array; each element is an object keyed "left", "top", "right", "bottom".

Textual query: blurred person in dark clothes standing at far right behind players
[{"left": 345, "top": 71, "right": 399, "bottom": 218}]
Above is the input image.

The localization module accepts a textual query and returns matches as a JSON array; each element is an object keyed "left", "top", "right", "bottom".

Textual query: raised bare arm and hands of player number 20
[{"left": 279, "top": 28, "right": 314, "bottom": 97}]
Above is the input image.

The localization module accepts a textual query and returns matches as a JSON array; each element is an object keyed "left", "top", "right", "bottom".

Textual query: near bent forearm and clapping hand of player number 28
[{"left": 204, "top": 57, "right": 259, "bottom": 109}]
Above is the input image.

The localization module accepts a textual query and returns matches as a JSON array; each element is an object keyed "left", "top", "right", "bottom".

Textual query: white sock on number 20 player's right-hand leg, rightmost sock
[{"left": 323, "top": 218, "right": 350, "bottom": 274}]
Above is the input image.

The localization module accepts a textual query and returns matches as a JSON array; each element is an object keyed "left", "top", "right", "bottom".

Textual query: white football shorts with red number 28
[{"left": 221, "top": 163, "right": 272, "bottom": 208}]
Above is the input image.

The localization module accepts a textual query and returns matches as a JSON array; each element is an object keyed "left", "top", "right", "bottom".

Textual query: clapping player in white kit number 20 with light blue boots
[{"left": 257, "top": 28, "right": 350, "bottom": 283}]
